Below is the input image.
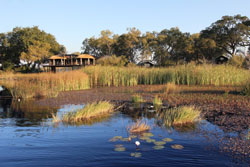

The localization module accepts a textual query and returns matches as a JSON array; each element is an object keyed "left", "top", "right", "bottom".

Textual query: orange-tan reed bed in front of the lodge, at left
[{"left": 0, "top": 70, "right": 89, "bottom": 98}]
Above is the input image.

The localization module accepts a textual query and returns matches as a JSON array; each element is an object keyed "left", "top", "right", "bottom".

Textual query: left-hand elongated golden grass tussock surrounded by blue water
[{"left": 62, "top": 101, "right": 114, "bottom": 123}]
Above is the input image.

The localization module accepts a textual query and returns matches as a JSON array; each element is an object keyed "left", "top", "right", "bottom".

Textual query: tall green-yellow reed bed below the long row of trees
[{"left": 83, "top": 64, "right": 250, "bottom": 87}]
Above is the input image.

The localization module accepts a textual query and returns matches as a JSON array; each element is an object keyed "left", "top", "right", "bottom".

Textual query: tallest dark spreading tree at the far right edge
[{"left": 201, "top": 15, "right": 250, "bottom": 57}]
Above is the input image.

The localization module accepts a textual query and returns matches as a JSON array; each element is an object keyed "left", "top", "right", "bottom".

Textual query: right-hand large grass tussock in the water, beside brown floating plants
[{"left": 161, "top": 106, "right": 201, "bottom": 126}]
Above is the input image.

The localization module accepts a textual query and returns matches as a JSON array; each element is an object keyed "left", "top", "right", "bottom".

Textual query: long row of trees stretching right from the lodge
[{"left": 82, "top": 15, "right": 250, "bottom": 66}]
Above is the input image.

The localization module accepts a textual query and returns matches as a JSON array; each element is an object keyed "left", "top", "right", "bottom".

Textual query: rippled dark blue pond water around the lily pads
[{"left": 0, "top": 99, "right": 249, "bottom": 167}]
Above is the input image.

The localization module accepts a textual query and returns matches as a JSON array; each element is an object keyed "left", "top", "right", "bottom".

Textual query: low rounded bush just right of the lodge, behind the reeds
[{"left": 97, "top": 55, "right": 128, "bottom": 66}]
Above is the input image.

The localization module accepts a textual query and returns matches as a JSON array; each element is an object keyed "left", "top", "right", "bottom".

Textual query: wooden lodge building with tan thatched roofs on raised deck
[{"left": 43, "top": 54, "right": 95, "bottom": 72}]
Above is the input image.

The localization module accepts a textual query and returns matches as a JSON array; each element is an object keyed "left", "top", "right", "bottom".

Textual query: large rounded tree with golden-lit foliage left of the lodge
[{"left": 0, "top": 26, "right": 65, "bottom": 70}]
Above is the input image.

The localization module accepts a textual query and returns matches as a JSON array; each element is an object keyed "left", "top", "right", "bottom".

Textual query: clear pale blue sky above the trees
[{"left": 0, "top": 0, "right": 250, "bottom": 53}]
